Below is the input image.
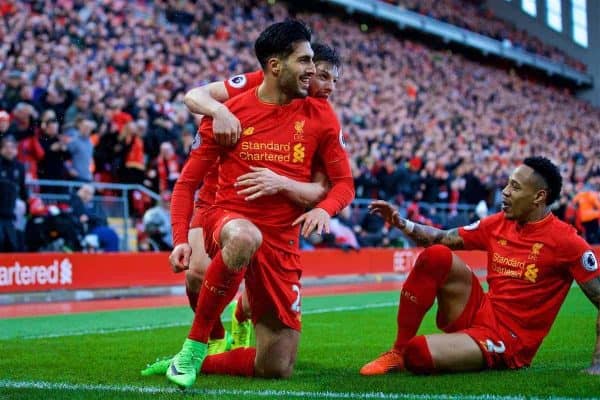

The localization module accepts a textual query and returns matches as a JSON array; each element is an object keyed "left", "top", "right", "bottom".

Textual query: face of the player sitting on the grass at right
[{"left": 502, "top": 165, "right": 541, "bottom": 222}]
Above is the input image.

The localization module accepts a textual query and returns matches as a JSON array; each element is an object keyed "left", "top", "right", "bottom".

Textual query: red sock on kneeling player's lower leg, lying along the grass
[{"left": 201, "top": 347, "right": 256, "bottom": 376}]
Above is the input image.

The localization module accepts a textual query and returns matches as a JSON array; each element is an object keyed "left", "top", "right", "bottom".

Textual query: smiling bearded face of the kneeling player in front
[{"left": 279, "top": 42, "right": 315, "bottom": 98}]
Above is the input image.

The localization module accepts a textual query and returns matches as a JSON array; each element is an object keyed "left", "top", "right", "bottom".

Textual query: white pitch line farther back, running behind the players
[{"left": 9, "top": 302, "right": 398, "bottom": 340}]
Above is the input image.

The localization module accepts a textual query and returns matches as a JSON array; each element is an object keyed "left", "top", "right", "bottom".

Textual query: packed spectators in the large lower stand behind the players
[{"left": 0, "top": 0, "right": 600, "bottom": 250}]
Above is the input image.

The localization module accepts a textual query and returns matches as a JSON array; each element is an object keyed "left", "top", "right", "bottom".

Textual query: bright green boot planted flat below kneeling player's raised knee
[{"left": 166, "top": 339, "right": 208, "bottom": 388}]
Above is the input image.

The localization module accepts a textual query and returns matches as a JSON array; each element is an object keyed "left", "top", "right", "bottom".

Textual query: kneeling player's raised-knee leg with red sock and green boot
[{"left": 167, "top": 213, "right": 262, "bottom": 387}]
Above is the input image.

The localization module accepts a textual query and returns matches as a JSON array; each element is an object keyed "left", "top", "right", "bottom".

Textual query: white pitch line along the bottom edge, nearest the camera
[{"left": 0, "top": 380, "right": 592, "bottom": 400}]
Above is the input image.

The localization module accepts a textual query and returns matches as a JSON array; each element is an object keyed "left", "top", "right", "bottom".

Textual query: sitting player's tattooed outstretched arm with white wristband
[{"left": 369, "top": 200, "right": 464, "bottom": 250}]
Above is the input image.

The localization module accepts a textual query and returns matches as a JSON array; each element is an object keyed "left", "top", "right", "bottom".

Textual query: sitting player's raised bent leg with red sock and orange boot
[{"left": 360, "top": 245, "right": 472, "bottom": 375}]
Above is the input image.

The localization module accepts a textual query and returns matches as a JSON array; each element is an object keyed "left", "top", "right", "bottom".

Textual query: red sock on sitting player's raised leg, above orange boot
[{"left": 394, "top": 245, "right": 452, "bottom": 351}]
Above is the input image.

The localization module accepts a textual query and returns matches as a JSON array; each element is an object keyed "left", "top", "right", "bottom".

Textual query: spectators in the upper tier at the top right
[{"left": 386, "top": 0, "right": 587, "bottom": 71}]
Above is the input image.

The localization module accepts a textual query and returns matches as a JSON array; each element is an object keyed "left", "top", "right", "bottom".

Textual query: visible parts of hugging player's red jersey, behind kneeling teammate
[{"left": 195, "top": 70, "right": 265, "bottom": 207}]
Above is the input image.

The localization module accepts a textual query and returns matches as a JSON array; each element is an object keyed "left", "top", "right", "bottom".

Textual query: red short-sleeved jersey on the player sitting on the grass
[{"left": 458, "top": 213, "right": 600, "bottom": 364}]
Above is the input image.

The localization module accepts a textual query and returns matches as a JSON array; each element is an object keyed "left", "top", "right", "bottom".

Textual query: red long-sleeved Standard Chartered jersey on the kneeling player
[{"left": 171, "top": 90, "right": 354, "bottom": 252}]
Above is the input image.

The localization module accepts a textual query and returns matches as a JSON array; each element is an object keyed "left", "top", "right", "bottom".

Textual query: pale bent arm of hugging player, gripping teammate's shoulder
[{"left": 183, "top": 82, "right": 242, "bottom": 146}]
